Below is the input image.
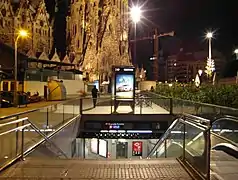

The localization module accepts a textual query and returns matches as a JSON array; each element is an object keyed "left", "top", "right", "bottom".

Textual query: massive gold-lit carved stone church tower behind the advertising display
[{"left": 67, "top": 0, "right": 130, "bottom": 81}]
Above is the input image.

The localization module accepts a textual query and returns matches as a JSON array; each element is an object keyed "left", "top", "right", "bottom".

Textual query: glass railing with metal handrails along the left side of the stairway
[{"left": 0, "top": 98, "right": 80, "bottom": 170}]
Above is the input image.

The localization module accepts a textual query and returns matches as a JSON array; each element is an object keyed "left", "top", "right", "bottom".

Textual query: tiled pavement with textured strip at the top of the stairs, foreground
[{"left": 0, "top": 158, "right": 192, "bottom": 180}]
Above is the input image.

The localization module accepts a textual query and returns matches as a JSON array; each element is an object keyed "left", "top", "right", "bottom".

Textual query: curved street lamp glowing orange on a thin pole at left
[{"left": 14, "top": 29, "right": 28, "bottom": 106}]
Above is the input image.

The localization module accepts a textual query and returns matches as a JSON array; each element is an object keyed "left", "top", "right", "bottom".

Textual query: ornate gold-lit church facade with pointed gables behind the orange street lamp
[{"left": 0, "top": 0, "right": 53, "bottom": 54}]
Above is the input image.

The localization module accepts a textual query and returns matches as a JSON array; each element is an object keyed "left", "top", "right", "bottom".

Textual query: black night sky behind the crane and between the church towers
[{"left": 48, "top": 0, "right": 238, "bottom": 62}]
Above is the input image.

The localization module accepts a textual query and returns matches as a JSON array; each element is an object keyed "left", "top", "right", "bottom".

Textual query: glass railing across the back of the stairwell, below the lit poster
[{"left": 80, "top": 96, "right": 172, "bottom": 114}]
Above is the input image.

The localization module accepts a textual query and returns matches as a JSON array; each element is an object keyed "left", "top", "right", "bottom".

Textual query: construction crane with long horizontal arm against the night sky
[{"left": 130, "top": 28, "right": 174, "bottom": 81}]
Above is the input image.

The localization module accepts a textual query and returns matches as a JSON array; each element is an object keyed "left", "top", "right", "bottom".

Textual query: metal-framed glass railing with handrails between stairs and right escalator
[{"left": 148, "top": 115, "right": 211, "bottom": 179}]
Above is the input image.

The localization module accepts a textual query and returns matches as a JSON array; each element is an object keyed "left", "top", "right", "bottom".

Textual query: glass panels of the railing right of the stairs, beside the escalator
[{"left": 149, "top": 119, "right": 210, "bottom": 177}]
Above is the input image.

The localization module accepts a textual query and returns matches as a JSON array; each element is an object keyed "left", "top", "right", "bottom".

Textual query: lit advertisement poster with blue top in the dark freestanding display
[{"left": 116, "top": 74, "right": 134, "bottom": 99}]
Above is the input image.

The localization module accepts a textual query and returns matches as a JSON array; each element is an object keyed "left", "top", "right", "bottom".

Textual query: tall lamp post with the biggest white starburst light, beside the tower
[{"left": 130, "top": 6, "right": 141, "bottom": 64}]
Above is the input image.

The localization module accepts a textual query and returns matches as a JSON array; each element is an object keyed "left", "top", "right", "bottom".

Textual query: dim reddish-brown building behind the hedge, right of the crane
[{"left": 167, "top": 49, "right": 225, "bottom": 82}]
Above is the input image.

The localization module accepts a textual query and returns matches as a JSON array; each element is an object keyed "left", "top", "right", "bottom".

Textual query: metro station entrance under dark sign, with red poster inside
[{"left": 76, "top": 114, "right": 172, "bottom": 159}]
